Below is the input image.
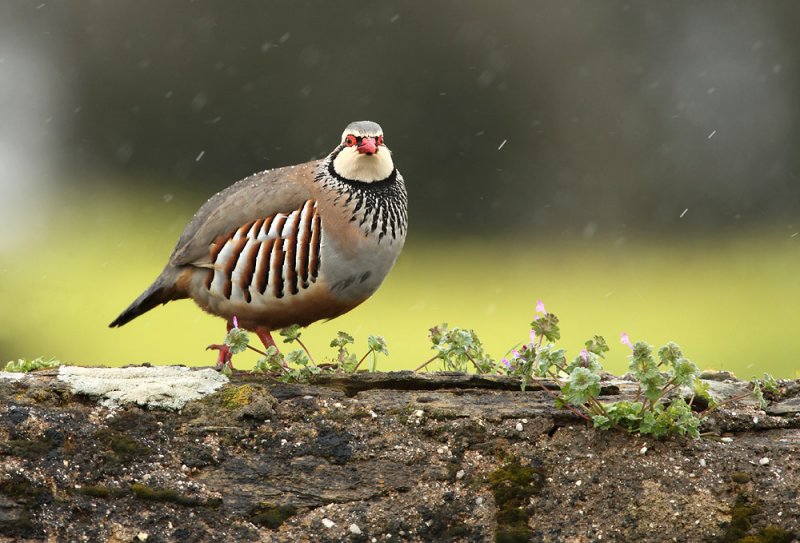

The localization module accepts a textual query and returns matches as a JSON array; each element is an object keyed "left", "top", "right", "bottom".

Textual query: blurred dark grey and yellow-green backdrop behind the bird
[{"left": 0, "top": 0, "right": 800, "bottom": 377}]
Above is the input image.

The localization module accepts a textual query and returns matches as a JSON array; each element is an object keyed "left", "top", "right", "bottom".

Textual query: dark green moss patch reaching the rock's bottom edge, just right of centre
[{"left": 489, "top": 458, "right": 544, "bottom": 543}]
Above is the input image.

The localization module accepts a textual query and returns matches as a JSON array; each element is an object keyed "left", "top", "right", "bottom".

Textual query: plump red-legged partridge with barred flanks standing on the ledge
[{"left": 109, "top": 121, "right": 408, "bottom": 369}]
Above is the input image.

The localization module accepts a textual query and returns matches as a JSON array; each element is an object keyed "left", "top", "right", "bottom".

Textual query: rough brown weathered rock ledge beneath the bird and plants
[{"left": 0, "top": 368, "right": 800, "bottom": 542}]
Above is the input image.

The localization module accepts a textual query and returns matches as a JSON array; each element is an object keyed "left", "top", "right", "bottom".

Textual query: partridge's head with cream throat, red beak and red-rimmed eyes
[{"left": 333, "top": 121, "right": 394, "bottom": 183}]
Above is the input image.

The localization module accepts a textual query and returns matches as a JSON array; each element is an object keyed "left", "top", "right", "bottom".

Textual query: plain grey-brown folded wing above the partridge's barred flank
[{"left": 170, "top": 161, "right": 320, "bottom": 266}]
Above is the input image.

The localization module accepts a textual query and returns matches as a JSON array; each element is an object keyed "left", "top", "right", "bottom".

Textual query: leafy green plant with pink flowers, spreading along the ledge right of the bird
[{"left": 422, "top": 301, "right": 710, "bottom": 437}]
